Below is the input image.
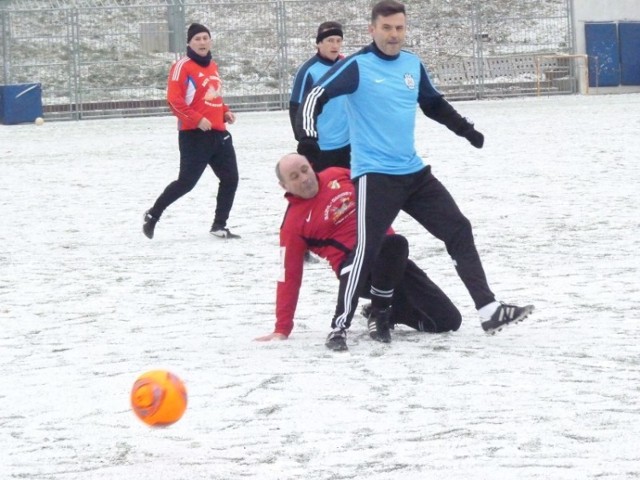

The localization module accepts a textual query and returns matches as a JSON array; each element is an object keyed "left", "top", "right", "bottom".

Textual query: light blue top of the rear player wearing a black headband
[{"left": 289, "top": 54, "right": 349, "bottom": 150}]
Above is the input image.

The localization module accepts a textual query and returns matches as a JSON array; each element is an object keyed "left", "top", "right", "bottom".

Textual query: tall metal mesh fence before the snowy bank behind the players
[{"left": 0, "top": 0, "right": 578, "bottom": 119}]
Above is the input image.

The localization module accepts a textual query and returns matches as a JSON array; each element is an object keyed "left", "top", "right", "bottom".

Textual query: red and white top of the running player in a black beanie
[{"left": 167, "top": 57, "right": 229, "bottom": 131}]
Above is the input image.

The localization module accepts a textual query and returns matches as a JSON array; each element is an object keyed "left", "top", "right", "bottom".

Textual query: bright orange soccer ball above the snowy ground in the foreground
[{"left": 131, "top": 370, "right": 187, "bottom": 427}]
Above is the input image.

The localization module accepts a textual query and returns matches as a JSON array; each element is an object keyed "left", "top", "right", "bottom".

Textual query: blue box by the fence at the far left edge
[{"left": 0, "top": 83, "right": 42, "bottom": 125}]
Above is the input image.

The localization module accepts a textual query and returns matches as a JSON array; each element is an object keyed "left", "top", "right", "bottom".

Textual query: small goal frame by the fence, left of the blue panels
[{"left": 536, "top": 54, "right": 589, "bottom": 96}]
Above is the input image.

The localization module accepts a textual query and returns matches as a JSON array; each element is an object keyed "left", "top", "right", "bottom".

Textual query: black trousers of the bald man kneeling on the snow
[{"left": 332, "top": 234, "right": 462, "bottom": 333}]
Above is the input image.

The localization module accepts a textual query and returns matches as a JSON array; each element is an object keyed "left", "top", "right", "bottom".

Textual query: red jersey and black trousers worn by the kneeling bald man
[{"left": 275, "top": 167, "right": 462, "bottom": 336}]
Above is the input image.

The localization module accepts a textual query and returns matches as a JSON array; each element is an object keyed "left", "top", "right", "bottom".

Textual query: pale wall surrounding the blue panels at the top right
[{"left": 571, "top": 0, "right": 640, "bottom": 93}]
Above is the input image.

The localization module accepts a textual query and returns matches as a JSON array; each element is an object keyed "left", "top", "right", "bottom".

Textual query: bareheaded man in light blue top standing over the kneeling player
[{"left": 295, "top": 0, "right": 533, "bottom": 350}]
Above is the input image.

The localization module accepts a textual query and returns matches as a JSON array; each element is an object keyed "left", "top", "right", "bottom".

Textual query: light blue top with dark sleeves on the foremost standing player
[{"left": 295, "top": 43, "right": 467, "bottom": 178}]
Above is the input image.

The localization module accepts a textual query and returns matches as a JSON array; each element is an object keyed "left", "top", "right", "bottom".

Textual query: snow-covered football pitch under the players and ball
[{"left": 0, "top": 95, "right": 640, "bottom": 480}]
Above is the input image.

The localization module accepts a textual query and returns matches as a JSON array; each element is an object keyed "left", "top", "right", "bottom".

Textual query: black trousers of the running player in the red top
[{"left": 149, "top": 129, "right": 238, "bottom": 227}]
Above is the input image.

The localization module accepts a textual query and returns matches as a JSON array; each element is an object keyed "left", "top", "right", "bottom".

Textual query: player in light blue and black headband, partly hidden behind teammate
[{"left": 289, "top": 22, "right": 351, "bottom": 172}]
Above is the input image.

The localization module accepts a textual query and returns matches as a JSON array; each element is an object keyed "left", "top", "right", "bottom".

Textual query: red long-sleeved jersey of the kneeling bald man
[{"left": 275, "top": 167, "right": 364, "bottom": 336}]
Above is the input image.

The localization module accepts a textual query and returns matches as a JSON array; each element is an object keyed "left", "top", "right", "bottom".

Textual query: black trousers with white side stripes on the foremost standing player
[{"left": 332, "top": 167, "right": 495, "bottom": 328}]
